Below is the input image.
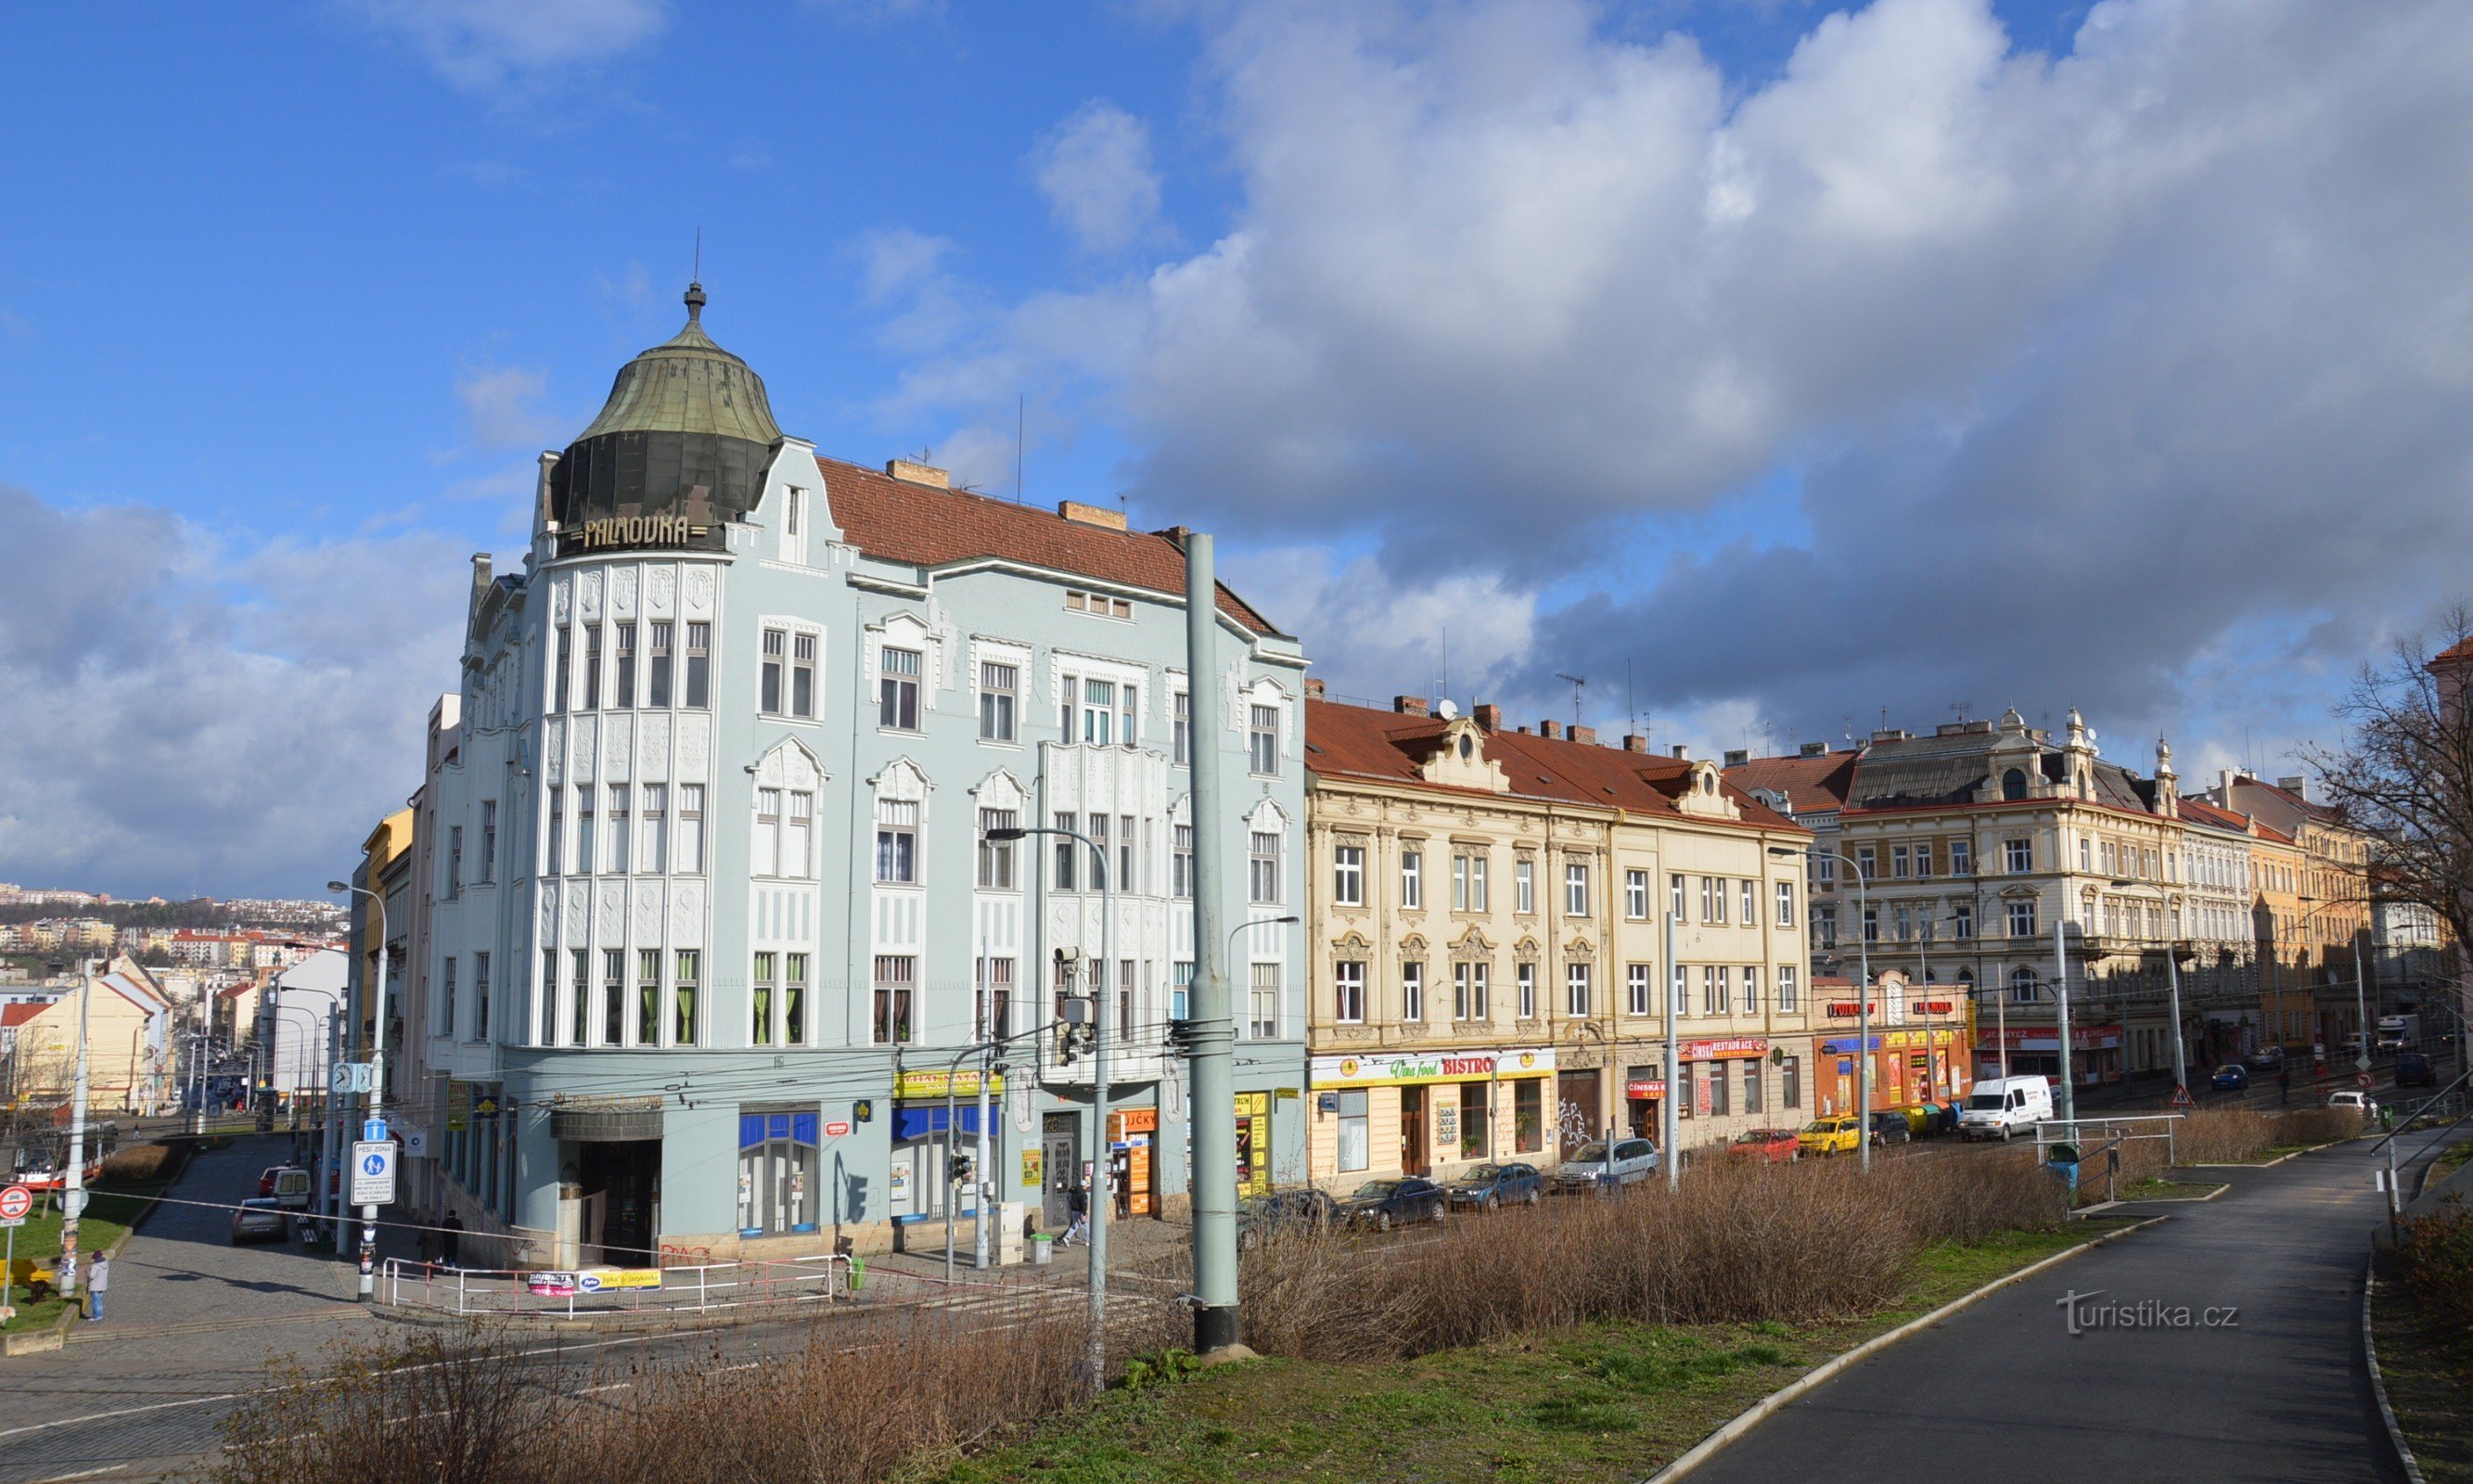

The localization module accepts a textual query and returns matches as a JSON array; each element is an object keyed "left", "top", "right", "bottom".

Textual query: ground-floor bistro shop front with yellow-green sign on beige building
[{"left": 1305, "top": 1046, "right": 1553, "bottom": 1187}]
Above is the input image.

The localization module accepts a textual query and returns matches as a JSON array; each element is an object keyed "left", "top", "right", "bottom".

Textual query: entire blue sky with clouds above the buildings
[{"left": 0, "top": 0, "right": 2473, "bottom": 895}]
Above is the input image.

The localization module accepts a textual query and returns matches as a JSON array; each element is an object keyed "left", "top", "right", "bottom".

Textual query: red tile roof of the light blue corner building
[{"left": 816, "top": 455, "right": 1278, "bottom": 633}]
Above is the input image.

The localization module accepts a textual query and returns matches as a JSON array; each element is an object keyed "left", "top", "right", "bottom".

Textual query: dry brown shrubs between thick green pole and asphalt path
[{"left": 1239, "top": 1153, "right": 2065, "bottom": 1361}]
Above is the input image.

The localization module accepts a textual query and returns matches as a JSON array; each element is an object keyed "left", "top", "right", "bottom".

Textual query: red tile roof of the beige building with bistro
[{"left": 1306, "top": 700, "right": 1808, "bottom": 834}]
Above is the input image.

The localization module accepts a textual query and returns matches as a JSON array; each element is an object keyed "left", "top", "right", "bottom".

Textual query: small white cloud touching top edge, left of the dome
[{"left": 341, "top": 0, "right": 670, "bottom": 92}]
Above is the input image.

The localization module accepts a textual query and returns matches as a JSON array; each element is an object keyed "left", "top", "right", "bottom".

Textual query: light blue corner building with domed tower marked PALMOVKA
[{"left": 396, "top": 289, "right": 1308, "bottom": 1266}]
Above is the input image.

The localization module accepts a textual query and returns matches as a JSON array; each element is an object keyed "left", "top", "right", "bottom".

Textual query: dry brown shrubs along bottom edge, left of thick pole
[{"left": 211, "top": 1298, "right": 1088, "bottom": 1484}]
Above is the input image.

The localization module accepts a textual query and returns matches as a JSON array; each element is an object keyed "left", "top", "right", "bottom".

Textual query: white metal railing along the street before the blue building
[{"left": 378, "top": 1254, "right": 855, "bottom": 1318}]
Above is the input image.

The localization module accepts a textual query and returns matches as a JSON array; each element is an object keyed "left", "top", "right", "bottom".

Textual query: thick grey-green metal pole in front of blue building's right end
[{"left": 1185, "top": 531, "right": 1236, "bottom": 1355}]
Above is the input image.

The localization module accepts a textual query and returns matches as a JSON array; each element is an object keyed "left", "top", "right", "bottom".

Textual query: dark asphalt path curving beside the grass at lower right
[{"left": 1694, "top": 1140, "right": 2433, "bottom": 1484}]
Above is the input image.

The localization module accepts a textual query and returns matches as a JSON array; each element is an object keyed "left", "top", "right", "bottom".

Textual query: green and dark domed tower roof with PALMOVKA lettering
[{"left": 549, "top": 285, "right": 781, "bottom": 549}]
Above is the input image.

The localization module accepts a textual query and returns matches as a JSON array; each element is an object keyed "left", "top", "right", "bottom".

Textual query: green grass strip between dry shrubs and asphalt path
[{"left": 900, "top": 1222, "right": 2124, "bottom": 1484}]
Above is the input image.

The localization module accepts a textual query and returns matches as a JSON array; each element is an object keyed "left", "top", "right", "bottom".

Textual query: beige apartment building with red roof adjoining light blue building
[{"left": 1306, "top": 695, "right": 1811, "bottom": 1187}]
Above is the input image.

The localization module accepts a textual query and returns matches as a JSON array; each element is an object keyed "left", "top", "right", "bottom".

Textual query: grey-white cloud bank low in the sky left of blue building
[{"left": 0, "top": 485, "right": 468, "bottom": 895}]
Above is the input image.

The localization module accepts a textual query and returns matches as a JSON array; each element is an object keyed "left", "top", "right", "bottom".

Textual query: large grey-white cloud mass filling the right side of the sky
[{"left": 875, "top": 0, "right": 2473, "bottom": 776}]
